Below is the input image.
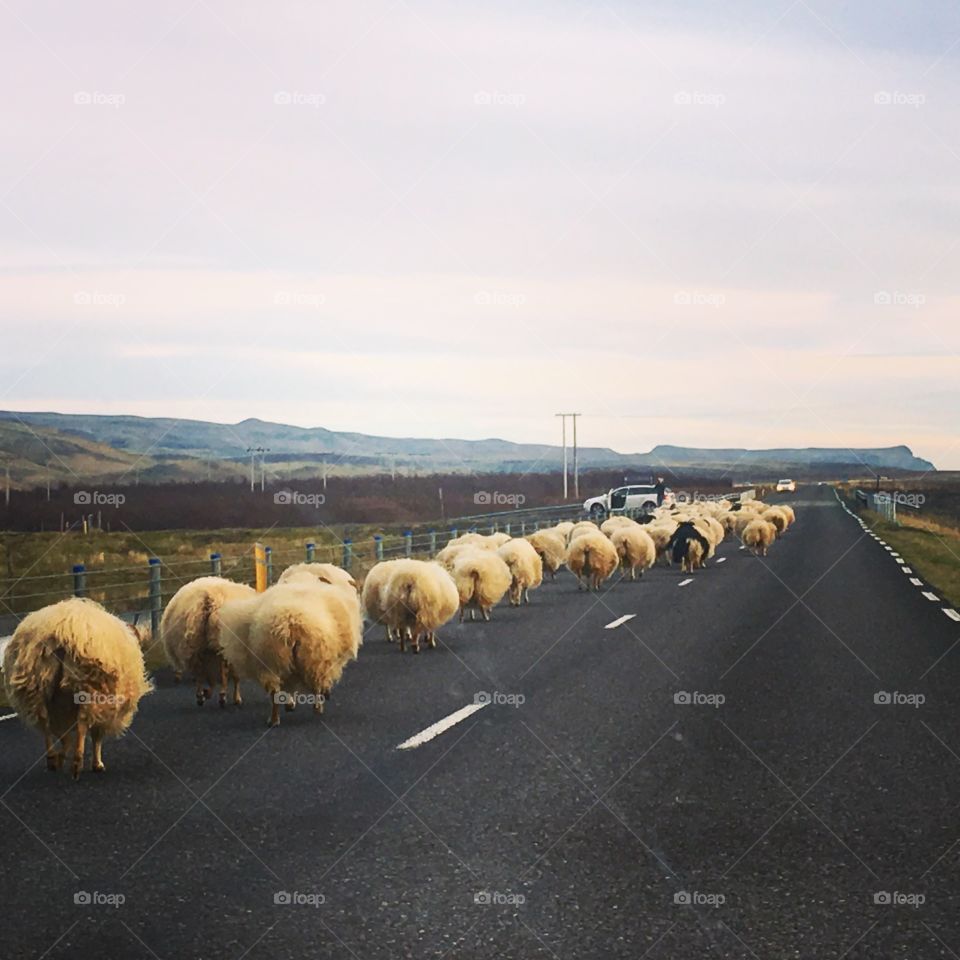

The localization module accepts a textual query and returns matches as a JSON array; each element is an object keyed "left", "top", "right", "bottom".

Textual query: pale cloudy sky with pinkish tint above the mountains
[{"left": 0, "top": 0, "right": 960, "bottom": 469}]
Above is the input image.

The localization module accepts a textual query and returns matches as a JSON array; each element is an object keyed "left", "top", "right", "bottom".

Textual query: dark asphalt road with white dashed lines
[{"left": 0, "top": 487, "right": 960, "bottom": 960}]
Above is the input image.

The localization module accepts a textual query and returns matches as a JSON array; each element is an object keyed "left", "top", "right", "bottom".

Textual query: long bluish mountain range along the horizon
[{"left": 0, "top": 411, "right": 935, "bottom": 485}]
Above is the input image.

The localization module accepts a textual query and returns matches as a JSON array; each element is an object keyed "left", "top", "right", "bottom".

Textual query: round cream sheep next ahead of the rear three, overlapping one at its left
[{"left": 379, "top": 559, "right": 460, "bottom": 653}]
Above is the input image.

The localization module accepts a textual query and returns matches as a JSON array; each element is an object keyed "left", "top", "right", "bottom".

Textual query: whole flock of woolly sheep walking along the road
[{"left": 3, "top": 500, "right": 795, "bottom": 778}]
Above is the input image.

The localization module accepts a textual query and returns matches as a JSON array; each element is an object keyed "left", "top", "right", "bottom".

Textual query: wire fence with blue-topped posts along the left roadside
[{"left": 0, "top": 505, "right": 583, "bottom": 636}]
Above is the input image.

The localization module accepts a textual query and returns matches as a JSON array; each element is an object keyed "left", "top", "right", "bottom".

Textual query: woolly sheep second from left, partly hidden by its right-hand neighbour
[{"left": 160, "top": 577, "right": 255, "bottom": 707}]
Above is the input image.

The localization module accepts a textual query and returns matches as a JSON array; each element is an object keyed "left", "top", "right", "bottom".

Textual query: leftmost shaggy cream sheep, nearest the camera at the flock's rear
[{"left": 3, "top": 597, "right": 153, "bottom": 780}]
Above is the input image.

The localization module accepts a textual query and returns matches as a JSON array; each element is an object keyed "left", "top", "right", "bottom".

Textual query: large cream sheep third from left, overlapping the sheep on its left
[{"left": 220, "top": 576, "right": 363, "bottom": 727}]
